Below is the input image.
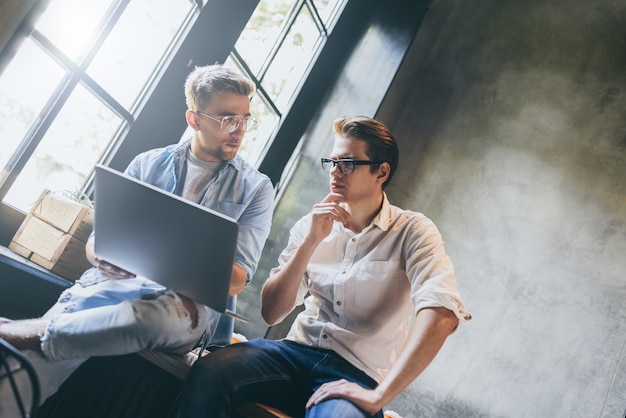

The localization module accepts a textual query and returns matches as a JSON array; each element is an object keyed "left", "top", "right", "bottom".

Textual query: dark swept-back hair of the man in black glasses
[{"left": 333, "top": 116, "right": 398, "bottom": 189}]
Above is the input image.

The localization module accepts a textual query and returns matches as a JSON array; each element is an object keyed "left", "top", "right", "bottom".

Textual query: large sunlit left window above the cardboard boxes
[{"left": 0, "top": 0, "right": 197, "bottom": 211}]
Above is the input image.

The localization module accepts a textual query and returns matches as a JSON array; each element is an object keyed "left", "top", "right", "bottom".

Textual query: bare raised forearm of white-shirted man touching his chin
[{"left": 261, "top": 241, "right": 317, "bottom": 326}]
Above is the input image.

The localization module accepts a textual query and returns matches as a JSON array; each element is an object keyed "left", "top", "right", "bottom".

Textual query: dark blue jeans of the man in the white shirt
[{"left": 173, "top": 339, "right": 383, "bottom": 418}]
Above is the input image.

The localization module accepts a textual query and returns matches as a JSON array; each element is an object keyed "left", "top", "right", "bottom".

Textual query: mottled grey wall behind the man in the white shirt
[{"left": 240, "top": 0, "right": 626, "bottom": 418}]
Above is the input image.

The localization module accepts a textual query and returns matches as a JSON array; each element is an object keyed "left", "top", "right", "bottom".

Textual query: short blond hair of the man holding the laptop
[{"left": 185, "top": 64, "right": 256, "bottom": 112}]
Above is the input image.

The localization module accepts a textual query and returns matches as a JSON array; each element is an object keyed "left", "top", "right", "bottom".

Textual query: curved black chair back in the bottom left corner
[{"left": 0, "top": 338, "right": 40, "bottom": 418}]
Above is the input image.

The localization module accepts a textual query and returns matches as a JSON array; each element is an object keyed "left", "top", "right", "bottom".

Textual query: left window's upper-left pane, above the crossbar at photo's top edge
[{"left": 36, "top": 0, "right": 111, "bottom": 62}]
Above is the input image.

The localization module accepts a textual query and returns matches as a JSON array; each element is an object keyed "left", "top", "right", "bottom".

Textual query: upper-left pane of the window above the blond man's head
[{"left": 235, "top": 0, "right": 294, "bottom": 76}]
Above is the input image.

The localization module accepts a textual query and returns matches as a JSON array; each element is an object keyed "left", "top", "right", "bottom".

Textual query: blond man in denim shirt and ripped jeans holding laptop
[{"left": 0, "top": 65, "right": 274, "bottom": 416}]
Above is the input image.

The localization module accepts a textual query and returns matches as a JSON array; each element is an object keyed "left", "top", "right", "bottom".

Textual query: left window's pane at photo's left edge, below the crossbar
[{"left": 0, "top": 39, "right": 64, "bottom": 182}]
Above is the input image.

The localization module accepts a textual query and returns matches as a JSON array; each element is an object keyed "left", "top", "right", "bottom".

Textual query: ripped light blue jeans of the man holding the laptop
[{"left": 0, "top": 269, "right": 220, "bottom": 417}]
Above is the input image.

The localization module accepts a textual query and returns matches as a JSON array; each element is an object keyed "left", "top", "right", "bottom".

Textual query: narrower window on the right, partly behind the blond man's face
[{"left": 185, "top": 0, "right": 344, "bottom": 166}]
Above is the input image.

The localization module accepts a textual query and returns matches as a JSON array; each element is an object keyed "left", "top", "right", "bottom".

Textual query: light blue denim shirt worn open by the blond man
[{"left": 126, "top": 139, "right": 274, "bottom": 282}]
